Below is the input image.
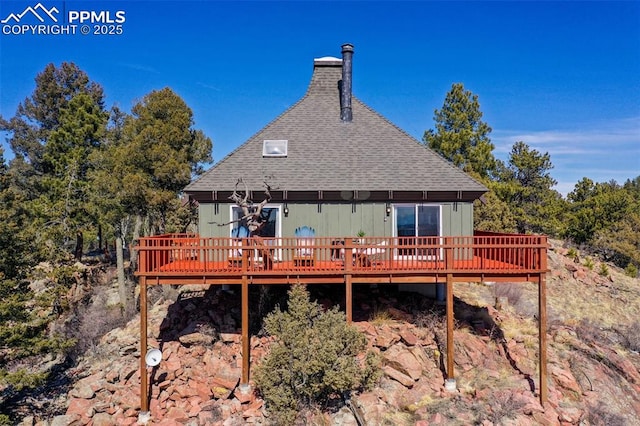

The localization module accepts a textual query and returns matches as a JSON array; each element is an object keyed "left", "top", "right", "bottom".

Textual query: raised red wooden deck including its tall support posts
[{"left": 136, "top": 231, "right": 548, "bottom": 411}]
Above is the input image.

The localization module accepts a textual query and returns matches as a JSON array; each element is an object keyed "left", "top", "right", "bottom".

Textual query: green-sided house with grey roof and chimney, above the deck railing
[{"left": 185, "top": 44, "right": 487, "bottom": 250}]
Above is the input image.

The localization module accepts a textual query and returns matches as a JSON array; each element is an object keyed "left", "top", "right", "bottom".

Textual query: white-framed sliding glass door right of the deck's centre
[{"left": 393, "top": 204, "right": 442, "bottom": 256}]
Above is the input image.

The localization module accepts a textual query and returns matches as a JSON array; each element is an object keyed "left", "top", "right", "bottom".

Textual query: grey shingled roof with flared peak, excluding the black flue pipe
[{"left": 185, "top": 46, "right": 487, "bottom": 201}]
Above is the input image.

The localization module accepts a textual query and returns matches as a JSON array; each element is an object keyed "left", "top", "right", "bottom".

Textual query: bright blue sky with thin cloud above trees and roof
[{"left": 0, "top": 0, "right": 640, "bottom": 194}]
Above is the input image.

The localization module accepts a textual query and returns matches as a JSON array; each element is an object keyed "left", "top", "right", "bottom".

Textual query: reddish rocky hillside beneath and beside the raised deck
[{"left": 16, "top": 242, "right": 640, "bottom": 426}]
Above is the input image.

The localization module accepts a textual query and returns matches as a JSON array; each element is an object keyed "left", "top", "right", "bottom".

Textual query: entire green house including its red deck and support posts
[{"left": 136, "top": 44, "right": 547, "bottom": 412}]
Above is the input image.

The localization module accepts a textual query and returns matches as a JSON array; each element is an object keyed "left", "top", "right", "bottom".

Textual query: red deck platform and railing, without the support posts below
[{"left": 137, "top": 232, "right": 547, "bottom": 277}]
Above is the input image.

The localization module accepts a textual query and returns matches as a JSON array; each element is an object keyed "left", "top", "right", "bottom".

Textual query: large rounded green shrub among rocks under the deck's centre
[{"left": 254, "top": 285, "right": 379, "bottom": 424}]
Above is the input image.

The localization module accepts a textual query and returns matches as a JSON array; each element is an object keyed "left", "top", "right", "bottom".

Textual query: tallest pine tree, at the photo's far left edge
[{"left": 1, "top": 62, "right": 105, "bottom": 259}]
